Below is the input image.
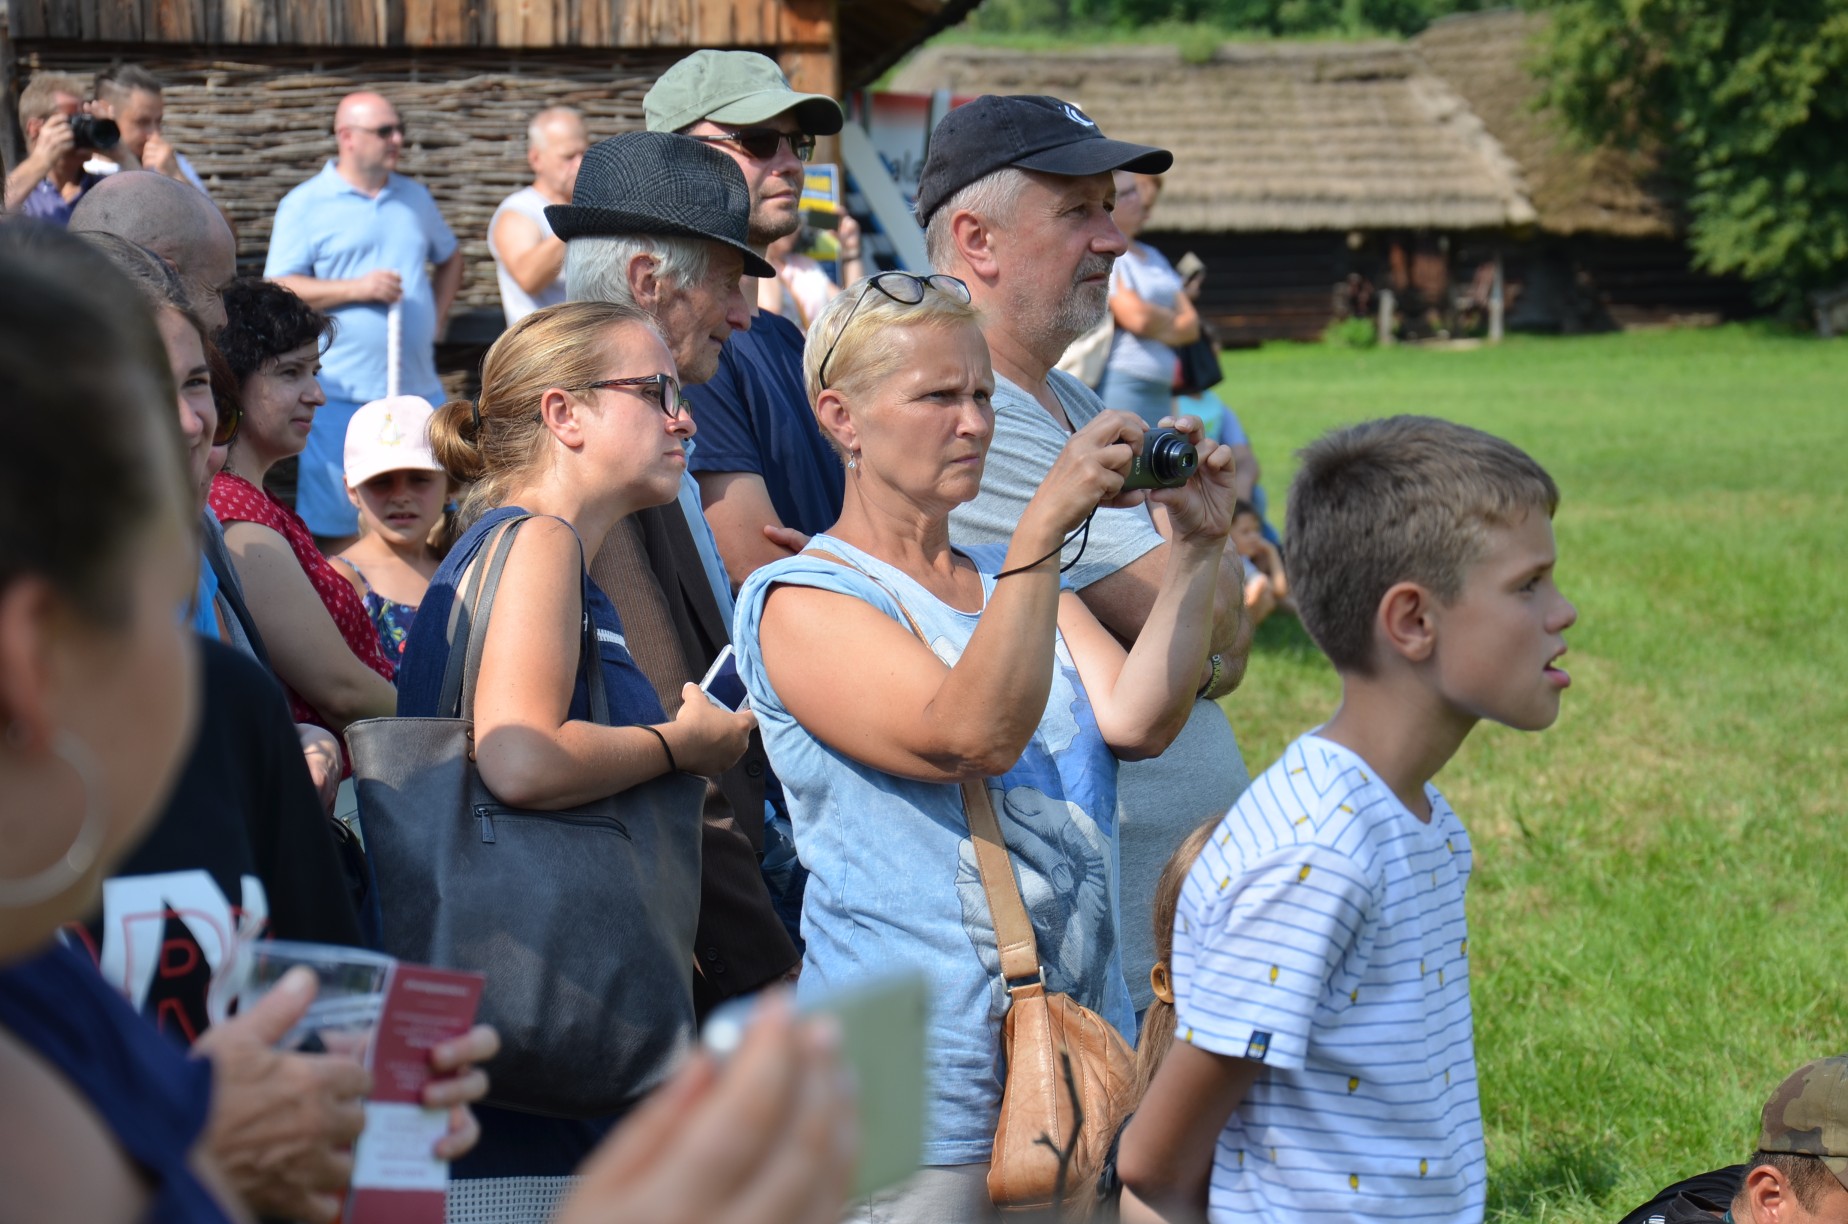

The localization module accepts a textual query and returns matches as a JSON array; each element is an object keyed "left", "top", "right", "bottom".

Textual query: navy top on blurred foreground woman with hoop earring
[{"left": 0, "top": 943, "right": 231, "bottom": 1224}]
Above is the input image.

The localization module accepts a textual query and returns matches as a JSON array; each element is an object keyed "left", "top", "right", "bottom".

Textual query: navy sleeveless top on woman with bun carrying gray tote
[{"left": 397, "top": 507, "right": 667, "bottom": 727}]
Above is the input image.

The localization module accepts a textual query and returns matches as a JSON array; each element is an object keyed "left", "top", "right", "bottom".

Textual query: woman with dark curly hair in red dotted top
[{"left": 211, "top": 279, "right": 397, "bottom": 734}]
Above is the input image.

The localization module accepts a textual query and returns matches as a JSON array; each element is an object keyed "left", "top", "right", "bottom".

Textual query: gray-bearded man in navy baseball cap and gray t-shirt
[{"left": 918, "top": 94, "right": 1251, "bottom": 1013}]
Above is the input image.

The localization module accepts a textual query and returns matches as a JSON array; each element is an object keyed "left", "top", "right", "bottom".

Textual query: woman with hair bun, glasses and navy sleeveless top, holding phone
[{"left": 397, "top": 301, "right": 756, "bottom": 1218}]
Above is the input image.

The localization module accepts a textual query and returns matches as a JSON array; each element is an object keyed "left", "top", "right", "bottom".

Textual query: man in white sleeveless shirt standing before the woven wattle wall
[{"left": 488, "top": 105, "right": 590, "bottom": 327}]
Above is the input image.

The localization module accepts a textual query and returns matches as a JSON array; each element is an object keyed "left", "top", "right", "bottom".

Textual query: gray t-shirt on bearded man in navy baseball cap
[{"left": 950, "top": 370, "right": 1251, "bottom": 1011}]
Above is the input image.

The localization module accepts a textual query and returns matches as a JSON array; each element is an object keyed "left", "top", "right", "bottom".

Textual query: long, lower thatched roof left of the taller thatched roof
[{"left": 893, "top": 43, "right": 1534, "bottom": 233}]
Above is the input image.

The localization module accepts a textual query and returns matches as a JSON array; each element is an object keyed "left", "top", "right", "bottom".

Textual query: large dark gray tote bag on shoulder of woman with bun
[{"left": 347, "top": 518, "right": 706, "bottom": 1119}]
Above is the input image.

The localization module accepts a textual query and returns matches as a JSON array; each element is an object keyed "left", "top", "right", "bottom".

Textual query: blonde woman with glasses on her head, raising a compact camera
[{"left": 734, "top": 272, "right": 1233, "bottom": 1224}]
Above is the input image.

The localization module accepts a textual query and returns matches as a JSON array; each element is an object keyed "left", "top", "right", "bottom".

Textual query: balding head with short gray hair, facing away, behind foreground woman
[{"left": 70, "top": 170, "right": 237, "bottom": 331}]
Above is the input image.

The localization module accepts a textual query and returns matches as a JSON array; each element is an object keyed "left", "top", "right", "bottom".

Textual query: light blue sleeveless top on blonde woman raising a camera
[{"left": 732, "top": 534, "right": 1135, "bottom": 1165}]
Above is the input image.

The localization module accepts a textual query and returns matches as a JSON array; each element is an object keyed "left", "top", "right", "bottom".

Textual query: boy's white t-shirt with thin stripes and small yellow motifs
[{"left": 1172, "top": 734, "right": 1486, "bottom": 1224}]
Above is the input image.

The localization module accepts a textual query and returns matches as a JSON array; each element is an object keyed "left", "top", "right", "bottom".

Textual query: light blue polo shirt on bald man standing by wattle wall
[{"left": 262, "top": 161, "right": 456, "bottom": 403}]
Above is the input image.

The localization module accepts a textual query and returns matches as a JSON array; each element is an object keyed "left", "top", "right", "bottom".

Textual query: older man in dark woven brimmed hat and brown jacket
[{"left": 545, "top": 131, "right": 798, "bottom": 1015}]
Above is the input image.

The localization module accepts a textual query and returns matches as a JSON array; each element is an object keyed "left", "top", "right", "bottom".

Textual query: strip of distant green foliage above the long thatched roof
[{"left": 972, "top": 0, "right": 1506, "bottom": 37}]
